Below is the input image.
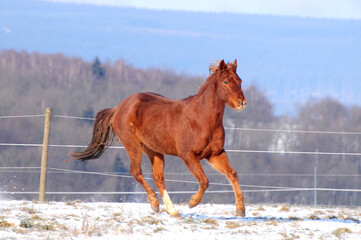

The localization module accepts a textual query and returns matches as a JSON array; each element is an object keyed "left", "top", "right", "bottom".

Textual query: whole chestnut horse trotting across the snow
[{"left": 70, "top": 60, "right": 246, "bottom": 217}]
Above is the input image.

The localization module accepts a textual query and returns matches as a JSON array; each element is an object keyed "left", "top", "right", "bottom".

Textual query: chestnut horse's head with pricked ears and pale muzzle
[{"left": 210, "top": 59, "right": 247, "bottom": 110}]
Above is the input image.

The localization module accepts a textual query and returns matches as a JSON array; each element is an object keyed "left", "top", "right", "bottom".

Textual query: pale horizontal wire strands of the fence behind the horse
[{"left": 0, "top": 111, "right": 361, "bottom": 203}]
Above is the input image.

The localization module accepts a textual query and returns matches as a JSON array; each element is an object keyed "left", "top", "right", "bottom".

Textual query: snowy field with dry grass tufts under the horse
[{"left": 0, "top": 201, "right": 361, "bottom": 240}]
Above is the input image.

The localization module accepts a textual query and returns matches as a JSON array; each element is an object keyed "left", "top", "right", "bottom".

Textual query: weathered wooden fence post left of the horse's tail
[{"left": 39, "top": 108, "right": 52, "bottom": 202}]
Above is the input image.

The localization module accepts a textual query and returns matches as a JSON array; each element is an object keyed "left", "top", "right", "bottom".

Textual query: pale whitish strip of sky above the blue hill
[{"left": 45, "top": 0, "right": 361, "bottom": 19}]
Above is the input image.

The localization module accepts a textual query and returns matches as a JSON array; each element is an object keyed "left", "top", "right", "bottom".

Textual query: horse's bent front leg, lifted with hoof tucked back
[{"left": 182, "top": 156, "right": 209, "bottom": 208}]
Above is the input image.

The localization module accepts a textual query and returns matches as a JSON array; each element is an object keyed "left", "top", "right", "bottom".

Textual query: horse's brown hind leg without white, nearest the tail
[{"left": 124, "top": 144, "right": 159, "bottom": 212}]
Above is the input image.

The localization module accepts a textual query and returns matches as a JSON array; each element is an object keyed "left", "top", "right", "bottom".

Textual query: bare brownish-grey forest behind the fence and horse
[{"left": 0, "top": 50, "right": 361, "bottom": 205}]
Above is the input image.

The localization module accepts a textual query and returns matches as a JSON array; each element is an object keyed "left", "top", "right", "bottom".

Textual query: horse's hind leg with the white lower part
[{"left": 144, "top": 147, "right": 179, "bottom": 217}]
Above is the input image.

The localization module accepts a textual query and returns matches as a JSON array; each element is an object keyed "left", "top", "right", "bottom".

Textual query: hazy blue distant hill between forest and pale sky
[{"left": 0, "top": 0, "right": 361, "bottom": 115}]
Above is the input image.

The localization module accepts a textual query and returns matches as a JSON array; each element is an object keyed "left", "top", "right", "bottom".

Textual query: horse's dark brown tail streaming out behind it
[{"left": 69, "top": 108, "right": 115, "bottom": 161}]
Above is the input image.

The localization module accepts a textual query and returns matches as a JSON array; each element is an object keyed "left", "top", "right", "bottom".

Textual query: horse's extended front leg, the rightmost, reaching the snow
[{"left": 207, "top": 150, "right": 246, "bottom": 217}]
